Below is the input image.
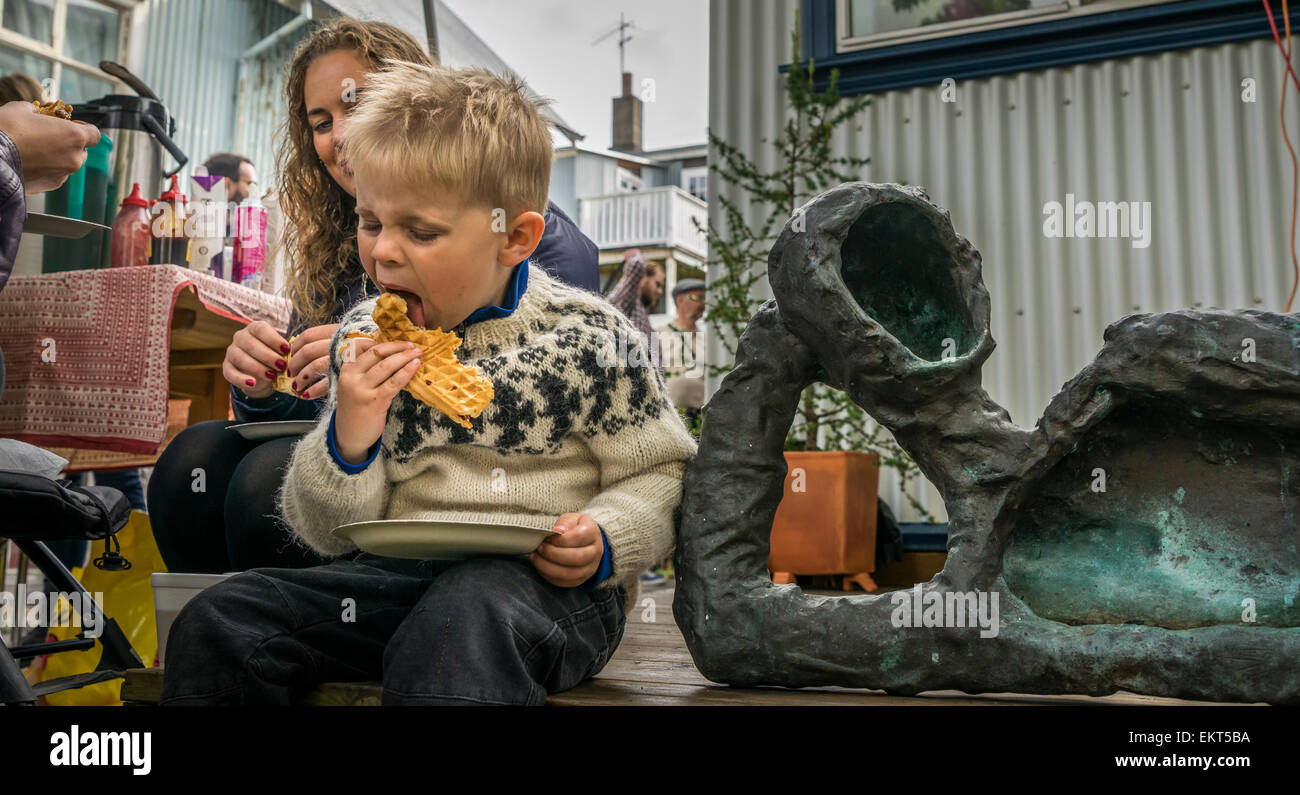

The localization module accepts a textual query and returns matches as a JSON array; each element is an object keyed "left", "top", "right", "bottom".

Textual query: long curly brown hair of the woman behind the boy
[{"left": 276, "top": 17, "right": 432, "bottom": 331}]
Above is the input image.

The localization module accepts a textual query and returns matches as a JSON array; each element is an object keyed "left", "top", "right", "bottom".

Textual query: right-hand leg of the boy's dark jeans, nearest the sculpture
[{"left": 382, "top": 557, "right": 625, "bottom": 705}]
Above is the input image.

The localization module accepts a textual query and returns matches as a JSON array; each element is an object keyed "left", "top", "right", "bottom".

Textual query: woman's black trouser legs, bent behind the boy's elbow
[{"left": 142, "top": 420, "right": 324, "bottom": 574}]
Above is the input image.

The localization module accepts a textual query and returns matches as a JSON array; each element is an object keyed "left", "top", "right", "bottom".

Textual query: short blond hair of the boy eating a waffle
[{"left": 343, "top": 61, "right": 551, "bottom": 218}]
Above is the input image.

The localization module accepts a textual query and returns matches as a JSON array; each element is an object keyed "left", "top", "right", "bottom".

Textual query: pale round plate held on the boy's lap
[{"left": 333, "top": 520, "right": 554, "bottom": 560}]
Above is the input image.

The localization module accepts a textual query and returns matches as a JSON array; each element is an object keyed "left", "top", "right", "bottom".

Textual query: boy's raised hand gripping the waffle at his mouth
[{"left": 335, "top": 338, "right": 424, "bottom": 464}]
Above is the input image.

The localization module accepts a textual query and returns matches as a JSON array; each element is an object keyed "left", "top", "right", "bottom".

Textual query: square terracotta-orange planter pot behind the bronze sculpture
[{"left": 768, "top": 451, "right": 880, "bottom": 591}]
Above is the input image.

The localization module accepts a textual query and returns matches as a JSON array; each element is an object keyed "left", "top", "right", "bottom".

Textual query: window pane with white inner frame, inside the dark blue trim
[{"left": 837, "top": 0, "right": 1170, "bottom": 52}]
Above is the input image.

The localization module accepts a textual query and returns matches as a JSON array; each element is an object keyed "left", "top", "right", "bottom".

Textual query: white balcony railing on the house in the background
[{"left": 579, "top": 186, "right": 709, "bottom": 260}]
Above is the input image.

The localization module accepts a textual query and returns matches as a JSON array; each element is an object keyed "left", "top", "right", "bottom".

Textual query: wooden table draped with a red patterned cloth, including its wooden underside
[{"left": 0, "top": 265, "right": 290, "bottom": 473}]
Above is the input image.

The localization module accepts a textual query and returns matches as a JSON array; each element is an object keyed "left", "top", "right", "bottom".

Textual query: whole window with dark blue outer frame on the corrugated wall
[{"left": 795, "top": 0, "right": 1253, "bottom": 96}]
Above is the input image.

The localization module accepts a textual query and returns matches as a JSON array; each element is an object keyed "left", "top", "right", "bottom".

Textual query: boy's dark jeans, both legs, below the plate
[{"left": 160, "top": 553, "right": 625, "bottom": 705}]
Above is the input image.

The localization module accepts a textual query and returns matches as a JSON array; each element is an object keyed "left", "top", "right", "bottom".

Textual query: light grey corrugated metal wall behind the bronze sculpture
[{"left": 709, "top": 0, "right": 1300, "bottom": 521}]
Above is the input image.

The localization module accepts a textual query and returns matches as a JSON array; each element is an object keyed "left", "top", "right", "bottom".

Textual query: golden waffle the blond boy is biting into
[{"left": 347, "top": 292, "right": 494, "bottom": 427}]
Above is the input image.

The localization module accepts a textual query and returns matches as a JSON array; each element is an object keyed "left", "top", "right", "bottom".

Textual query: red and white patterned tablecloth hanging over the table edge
[{"left": 0, "top": 265, "right": 290, "bottom": 453}]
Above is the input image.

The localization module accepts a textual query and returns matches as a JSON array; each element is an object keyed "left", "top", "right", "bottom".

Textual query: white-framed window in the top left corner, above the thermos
[{"left": 0, "top": 0, "right": 126, "bottom": 105}]
